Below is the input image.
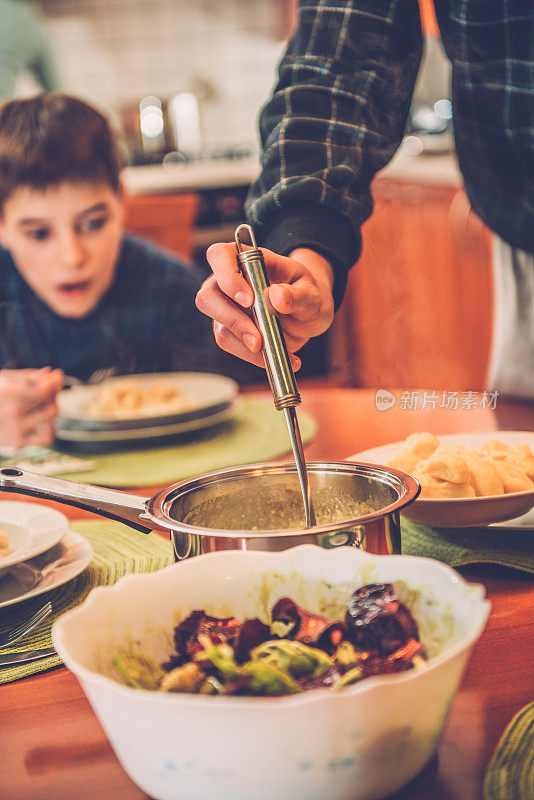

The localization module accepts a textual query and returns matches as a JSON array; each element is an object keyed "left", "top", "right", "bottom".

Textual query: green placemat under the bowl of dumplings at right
[{"left": 401, "top": 517, "right": 534, "bottom": 572}]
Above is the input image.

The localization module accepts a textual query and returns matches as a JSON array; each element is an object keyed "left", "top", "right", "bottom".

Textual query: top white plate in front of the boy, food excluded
[{"left": 57, "top": 372, "right": 239, "bottom": 432}]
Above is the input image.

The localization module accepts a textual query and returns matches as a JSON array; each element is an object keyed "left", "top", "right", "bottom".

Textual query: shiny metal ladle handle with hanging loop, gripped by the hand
[{"left": 235, "top": 225, "right": 301, "bottom": 411}]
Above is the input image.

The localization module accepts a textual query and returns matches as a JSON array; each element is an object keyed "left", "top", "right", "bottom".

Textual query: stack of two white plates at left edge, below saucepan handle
[{"left": 0, "top": 500, "right": 93, "bottom": 608}]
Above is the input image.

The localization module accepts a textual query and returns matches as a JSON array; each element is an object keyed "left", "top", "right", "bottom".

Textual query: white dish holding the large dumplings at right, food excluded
[{"left": 347, "top": 431, "right": 534, "bottom": 531}]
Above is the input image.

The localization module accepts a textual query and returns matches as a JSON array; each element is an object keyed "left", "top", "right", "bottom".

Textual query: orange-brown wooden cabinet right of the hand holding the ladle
[{"left": 329, "top": 177, "right": 493, "bottom": 391}]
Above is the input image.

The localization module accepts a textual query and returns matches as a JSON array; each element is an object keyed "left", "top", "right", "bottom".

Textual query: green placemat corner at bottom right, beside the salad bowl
[{"left": 484, "top": 703, "right": 534, "bottom": 800}]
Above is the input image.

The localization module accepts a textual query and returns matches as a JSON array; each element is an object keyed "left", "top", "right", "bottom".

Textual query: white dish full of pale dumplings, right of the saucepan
[{"left": 348, "top": 431, "right": 534, "bottom": 530}]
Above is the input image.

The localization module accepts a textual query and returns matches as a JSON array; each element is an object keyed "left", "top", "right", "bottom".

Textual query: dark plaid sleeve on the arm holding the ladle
[{"left": 247, "top": 0, "right": 422, "bottom": 302}]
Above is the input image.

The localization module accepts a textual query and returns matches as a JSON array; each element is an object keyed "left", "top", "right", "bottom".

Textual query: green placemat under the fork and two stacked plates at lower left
[{"left": 0, "top": 520, "right": 174, "bottom": 684}]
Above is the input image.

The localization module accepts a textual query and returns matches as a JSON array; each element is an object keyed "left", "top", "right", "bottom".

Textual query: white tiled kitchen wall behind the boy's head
[{"left": 41, "top": 0, "right": 283, "bottom": 155}]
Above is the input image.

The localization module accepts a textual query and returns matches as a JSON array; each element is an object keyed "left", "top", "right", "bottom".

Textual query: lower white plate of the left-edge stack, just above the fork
[{"left": 0, "top": 530, "right": 93, "bottom": 608}]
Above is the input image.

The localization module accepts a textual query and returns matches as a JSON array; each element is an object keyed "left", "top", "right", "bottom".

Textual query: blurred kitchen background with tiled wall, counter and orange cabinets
[{"left": 4, "top": 0, "right": 491, "bottom": 390}]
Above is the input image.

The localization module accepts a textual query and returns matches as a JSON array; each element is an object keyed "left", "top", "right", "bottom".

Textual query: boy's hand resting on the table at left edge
[{"left": 0, "top": 367, "right": 63, "bottom": 449}]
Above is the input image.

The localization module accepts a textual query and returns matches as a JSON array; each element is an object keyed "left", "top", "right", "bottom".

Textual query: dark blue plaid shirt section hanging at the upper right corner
[{"left": 435, "top": 0, "right": 534, "bottom": 253}]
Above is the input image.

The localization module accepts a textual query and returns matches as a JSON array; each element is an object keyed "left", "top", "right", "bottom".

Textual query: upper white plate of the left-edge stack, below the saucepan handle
[{"left": 0, "top": 500, "right": 69, "bottom": 576}]
